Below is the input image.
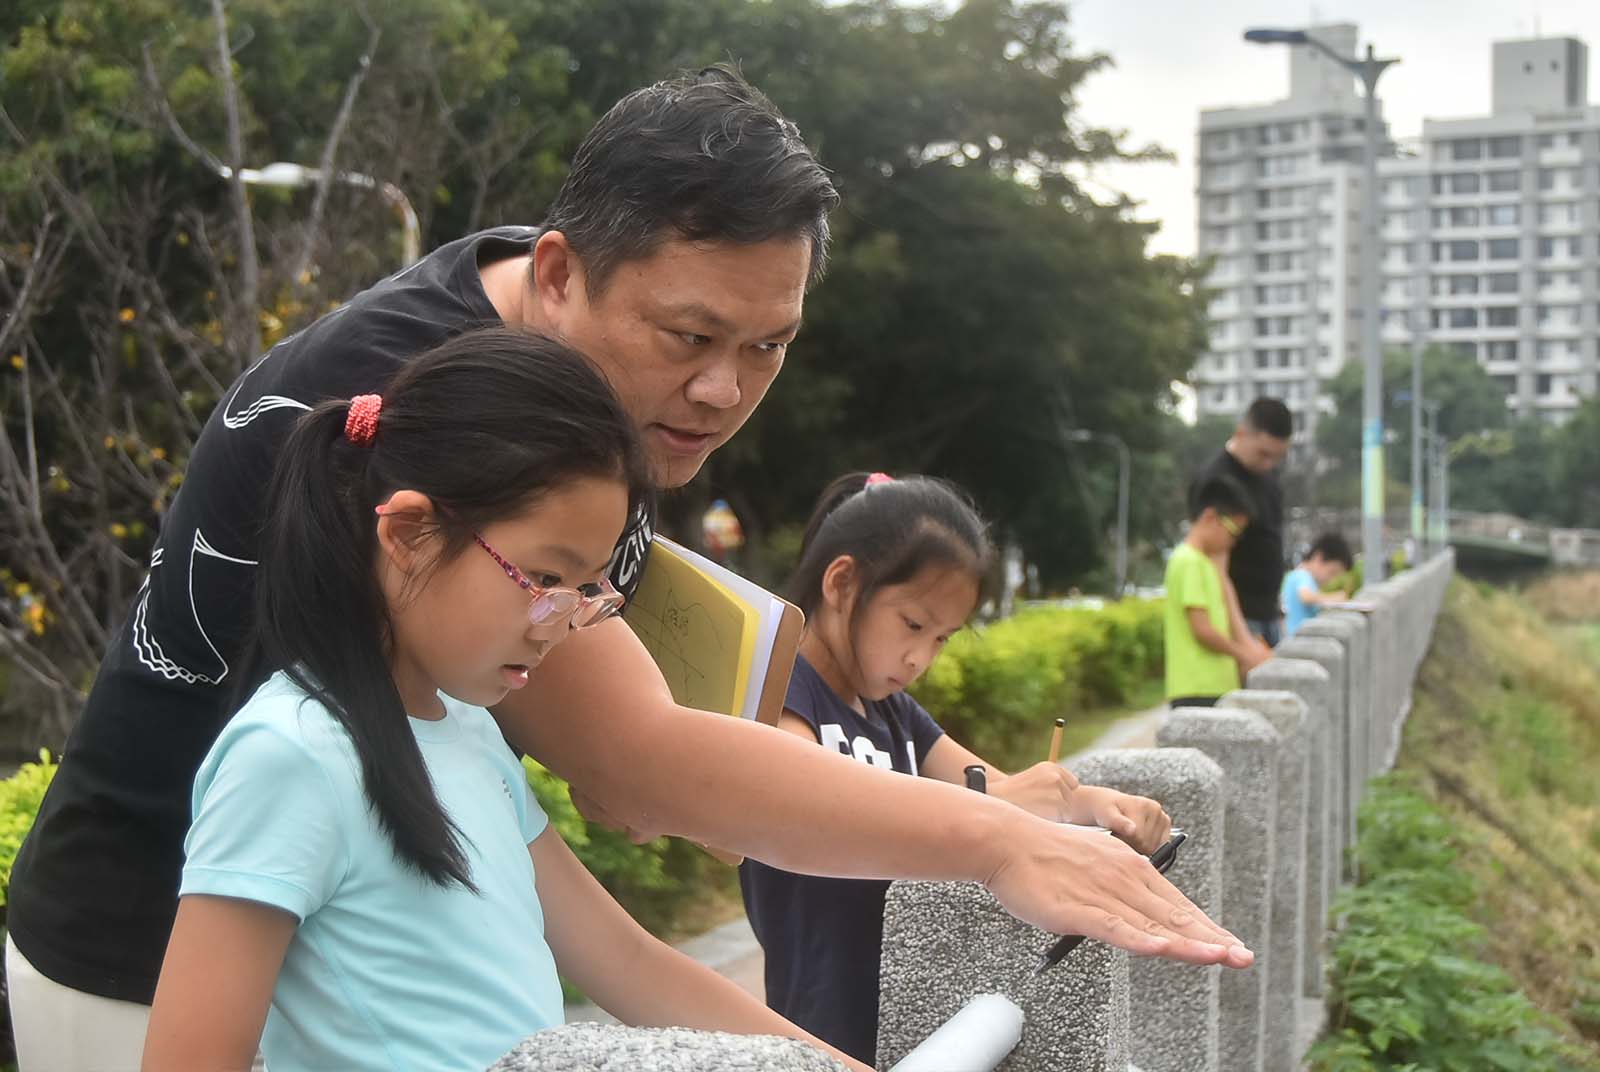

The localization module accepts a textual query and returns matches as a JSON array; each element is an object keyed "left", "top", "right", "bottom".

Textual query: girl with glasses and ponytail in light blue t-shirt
[{"left": 144, "top": 328, "right": 867, "bottom": 1072}]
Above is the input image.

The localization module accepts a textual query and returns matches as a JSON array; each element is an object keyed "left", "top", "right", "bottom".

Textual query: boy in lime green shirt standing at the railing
[{"left": 1165, "top": 477, "right": 1264, "bottom": 707}]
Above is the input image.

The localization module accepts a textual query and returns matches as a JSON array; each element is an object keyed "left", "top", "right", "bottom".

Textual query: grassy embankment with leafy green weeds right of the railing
[{"left": 1314, "top": 574, "right": 1600, "bottom": 1072}]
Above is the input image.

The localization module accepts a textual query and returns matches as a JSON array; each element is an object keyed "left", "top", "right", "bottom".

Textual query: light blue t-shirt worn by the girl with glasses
[{"left": 181, "top": 674, "right": 562, "bottom": 1072}]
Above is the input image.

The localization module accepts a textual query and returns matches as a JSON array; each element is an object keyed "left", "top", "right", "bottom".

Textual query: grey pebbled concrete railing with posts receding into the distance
[{"left": 878, "top": 552, "right": 1454, "bottom": 1072}]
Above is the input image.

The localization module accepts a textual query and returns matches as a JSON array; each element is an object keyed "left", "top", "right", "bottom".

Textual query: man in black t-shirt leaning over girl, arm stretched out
[{"left": 6, "top": 69, "right": 1251, "bottom": 1072}]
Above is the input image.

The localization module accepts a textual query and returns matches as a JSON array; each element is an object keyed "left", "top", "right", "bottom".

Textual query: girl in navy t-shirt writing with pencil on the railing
[{"left": 739, "top": 474, "right": 1171, "bottom": 1064}]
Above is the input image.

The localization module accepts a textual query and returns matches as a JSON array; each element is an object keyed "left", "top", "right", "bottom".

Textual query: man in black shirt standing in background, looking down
[{"left": 1189, "top": 398, "right": 1294, "bottom": 645}]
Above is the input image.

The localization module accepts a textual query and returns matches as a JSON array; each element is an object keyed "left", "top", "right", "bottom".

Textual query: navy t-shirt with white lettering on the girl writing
[{"left": 739, "top": 658, "right": 944, "bottom": 1064}]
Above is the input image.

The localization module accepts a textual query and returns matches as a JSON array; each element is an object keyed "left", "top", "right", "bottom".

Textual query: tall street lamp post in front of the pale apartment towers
[{"left": 1245, "top": 29, "right": 1398, "bottom": 582}]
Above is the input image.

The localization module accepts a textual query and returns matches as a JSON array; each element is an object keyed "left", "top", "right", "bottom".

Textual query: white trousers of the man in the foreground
[{"left": 5, "top": 934, "right": 266, "bottom": 1072}]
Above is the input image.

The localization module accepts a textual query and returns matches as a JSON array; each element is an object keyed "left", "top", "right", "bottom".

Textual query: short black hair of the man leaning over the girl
[{"left": 546, "top": 64, "right": 838, "bottom": 294}]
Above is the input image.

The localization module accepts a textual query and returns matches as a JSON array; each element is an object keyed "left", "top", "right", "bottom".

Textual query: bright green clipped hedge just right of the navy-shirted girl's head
[{"left": 912, "top": 598, "right": 1162, "bottom": 755}]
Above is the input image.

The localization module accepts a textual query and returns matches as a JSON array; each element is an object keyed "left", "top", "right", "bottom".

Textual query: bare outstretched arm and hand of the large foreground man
[{"left": 496, "top": 621, "right": 1253, "bottom": 966}]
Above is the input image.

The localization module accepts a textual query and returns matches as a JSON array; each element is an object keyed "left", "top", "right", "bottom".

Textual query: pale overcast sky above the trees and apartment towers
[{"left": 1072, "top": 0, "right": 1600, "bottom": 253}]
